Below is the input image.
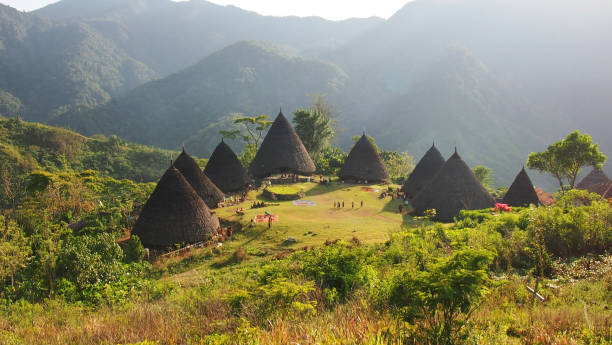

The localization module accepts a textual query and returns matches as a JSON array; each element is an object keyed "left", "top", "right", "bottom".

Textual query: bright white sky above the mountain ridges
[{"left": 0, "top": 0, "right": 409, "bottom": 20}]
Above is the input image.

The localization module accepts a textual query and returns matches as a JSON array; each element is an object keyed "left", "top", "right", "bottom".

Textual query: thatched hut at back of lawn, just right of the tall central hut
[{"left": 338, "top": 133, "right": 389, "bottom": 182}]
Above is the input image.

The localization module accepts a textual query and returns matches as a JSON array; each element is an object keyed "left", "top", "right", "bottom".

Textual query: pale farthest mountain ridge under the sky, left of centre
[{"left": 35, "top": 0, "right": 382, "bottom": 76}]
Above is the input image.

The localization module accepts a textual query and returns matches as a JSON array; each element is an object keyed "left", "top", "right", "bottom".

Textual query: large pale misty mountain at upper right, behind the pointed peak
[{"left": 327, "top": 0, "right": 612, "bottom": 173}]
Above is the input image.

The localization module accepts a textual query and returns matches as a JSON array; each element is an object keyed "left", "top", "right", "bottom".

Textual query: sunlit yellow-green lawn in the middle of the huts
[{"left": 215, "top": 183, "right": 415, "bottom": 250}]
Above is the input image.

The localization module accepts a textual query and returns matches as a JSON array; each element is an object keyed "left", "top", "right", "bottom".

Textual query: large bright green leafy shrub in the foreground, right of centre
[{"left": 388, "top": 249, "right": 492, "bottom": 344}]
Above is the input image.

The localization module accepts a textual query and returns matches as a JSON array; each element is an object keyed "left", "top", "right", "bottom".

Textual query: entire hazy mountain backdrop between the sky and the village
[{"left": 0, "top": 0, "right": 612, "bottom": 185}]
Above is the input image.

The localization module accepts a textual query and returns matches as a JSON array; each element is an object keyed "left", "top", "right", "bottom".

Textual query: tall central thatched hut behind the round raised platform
[{"left": 249, "top": 110, "right": 315, "bottom": 177}]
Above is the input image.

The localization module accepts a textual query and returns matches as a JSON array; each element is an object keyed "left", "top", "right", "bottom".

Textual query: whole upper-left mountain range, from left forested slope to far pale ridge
[{"left": 0, "top": 0, "right": 381, "bottom": 121}]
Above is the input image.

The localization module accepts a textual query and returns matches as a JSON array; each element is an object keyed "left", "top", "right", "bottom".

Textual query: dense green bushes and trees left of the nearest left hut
[{"left": 0, "top": 170, "right": 153, "bottom": 304}]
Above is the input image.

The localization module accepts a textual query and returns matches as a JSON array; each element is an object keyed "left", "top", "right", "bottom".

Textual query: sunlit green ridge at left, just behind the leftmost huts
[{"left": 0, "top": 117, "right": 171, "bottom": 182}]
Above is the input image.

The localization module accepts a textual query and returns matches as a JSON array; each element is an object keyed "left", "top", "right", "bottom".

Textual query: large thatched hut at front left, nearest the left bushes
[{"left": 132, "top": 167, "right": 219, "bottom": 248}]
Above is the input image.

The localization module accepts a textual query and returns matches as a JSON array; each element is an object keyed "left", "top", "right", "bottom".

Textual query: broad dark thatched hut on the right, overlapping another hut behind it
[{"left": 412, "top": 150, "right": 494, "bottom": 222}]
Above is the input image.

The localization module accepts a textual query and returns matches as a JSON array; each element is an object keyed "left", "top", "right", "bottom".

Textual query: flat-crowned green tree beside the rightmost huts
[{"left": 527, "top": 131, "right": 606, "bottom": 193}]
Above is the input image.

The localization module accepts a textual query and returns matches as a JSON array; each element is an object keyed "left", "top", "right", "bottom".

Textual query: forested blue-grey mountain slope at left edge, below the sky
[{"left": 0, "top": 5, "right": 155, "bottom": 121}]
